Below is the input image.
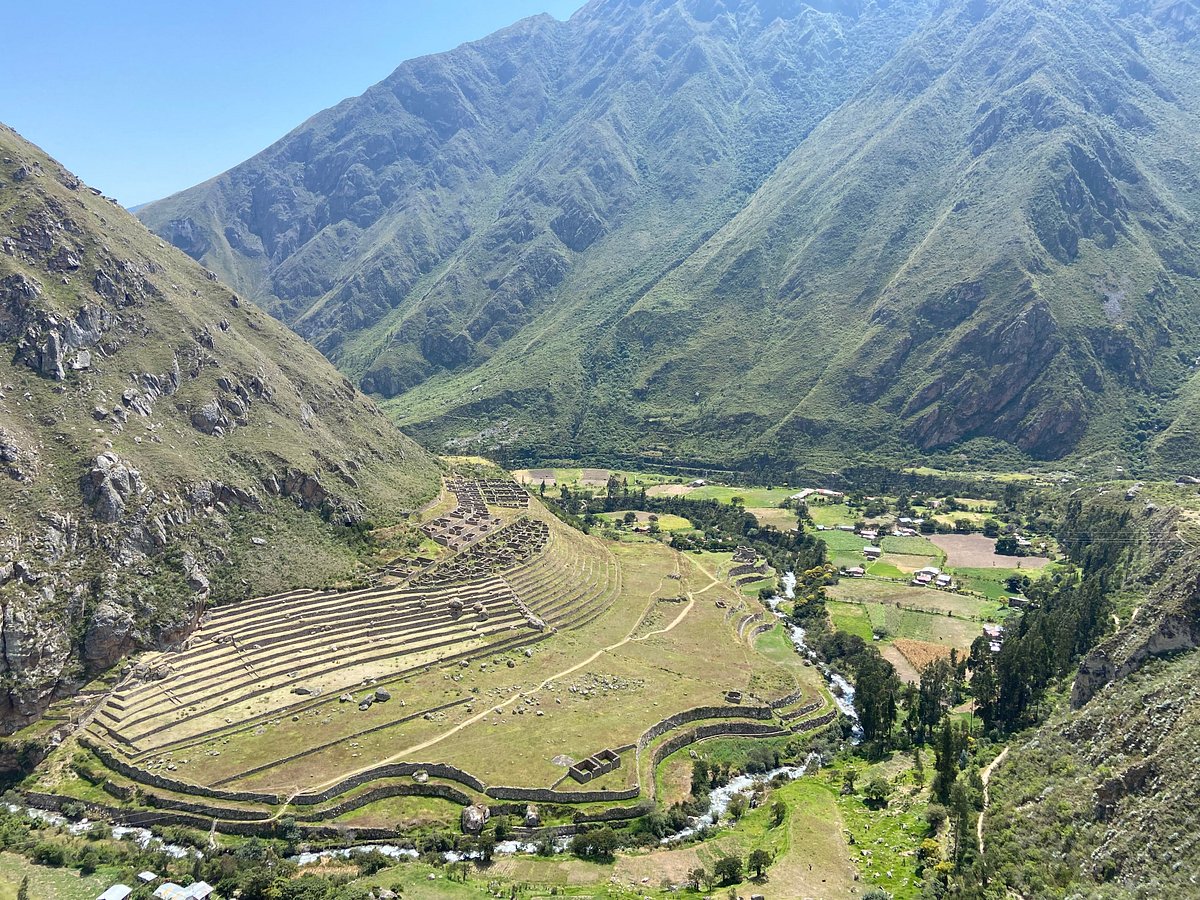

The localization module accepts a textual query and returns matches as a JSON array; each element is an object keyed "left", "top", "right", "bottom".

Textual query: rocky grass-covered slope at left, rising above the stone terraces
[{"left": 0, "top": 126, "right": 437, "bottom": 731}]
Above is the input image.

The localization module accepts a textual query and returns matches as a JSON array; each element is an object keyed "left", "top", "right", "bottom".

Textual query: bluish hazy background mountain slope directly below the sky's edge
[{"left": 139, "top": 0, "right": 934, "bottom": 420}]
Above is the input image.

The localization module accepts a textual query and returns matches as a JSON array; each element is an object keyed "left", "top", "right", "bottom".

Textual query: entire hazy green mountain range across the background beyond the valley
[{"left": 138, "top": 0, "right": 1200, "bottom": 467}]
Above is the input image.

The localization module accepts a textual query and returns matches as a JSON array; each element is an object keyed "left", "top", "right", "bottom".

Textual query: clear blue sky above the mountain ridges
[{"left": 0, "top": 0, "right": 583, "bottom": 206}]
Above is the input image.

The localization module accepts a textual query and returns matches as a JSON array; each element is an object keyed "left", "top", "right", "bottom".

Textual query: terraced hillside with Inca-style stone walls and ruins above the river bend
[{"left": 28, "top": 478, "right": 834, "bottom": 833}]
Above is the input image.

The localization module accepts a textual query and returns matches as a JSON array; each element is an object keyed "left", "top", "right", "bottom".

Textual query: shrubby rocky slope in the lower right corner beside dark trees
[{"left": 984, "top": 496, "right": 1200, "bottom": 898}]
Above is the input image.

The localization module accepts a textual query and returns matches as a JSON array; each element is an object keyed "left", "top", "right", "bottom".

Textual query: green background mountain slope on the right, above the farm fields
[{"left": 395, "top": 0, "right": 1200, "bottom": 463}]
